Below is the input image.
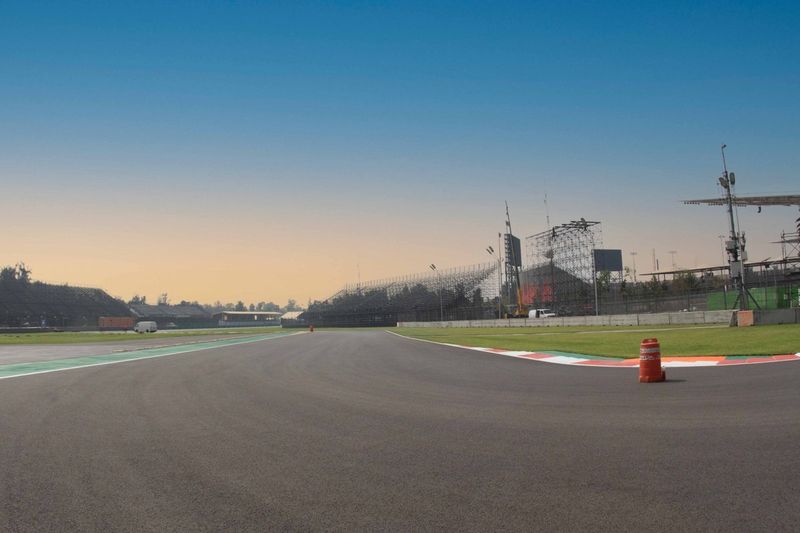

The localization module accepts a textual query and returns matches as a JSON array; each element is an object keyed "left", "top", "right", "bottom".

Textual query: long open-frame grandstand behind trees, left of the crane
[{"left": 303, "top": 262, "right": 501, "bottom": 326}]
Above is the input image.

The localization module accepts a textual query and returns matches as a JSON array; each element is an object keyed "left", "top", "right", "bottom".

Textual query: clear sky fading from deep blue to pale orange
[{"left": 0, "top": 0, "right": 800, "bottom": 303}]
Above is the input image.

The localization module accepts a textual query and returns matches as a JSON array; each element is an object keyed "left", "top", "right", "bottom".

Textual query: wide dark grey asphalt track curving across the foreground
[{"left": 0, "top": 331, "right": 800, "bottom": 531}]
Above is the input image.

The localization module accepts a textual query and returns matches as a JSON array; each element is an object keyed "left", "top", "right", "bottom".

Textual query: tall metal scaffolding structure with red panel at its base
[{"left": 522, "top": 218, "right": 602, "bottom": 315}]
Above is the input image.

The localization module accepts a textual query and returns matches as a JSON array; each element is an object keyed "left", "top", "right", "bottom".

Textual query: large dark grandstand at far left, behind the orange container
[{"left": 0, "top": 279, "right": 131, "bottom": 328}]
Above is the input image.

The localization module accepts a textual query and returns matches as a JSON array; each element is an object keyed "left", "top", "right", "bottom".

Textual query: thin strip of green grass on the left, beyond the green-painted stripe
[{"left": 0, "top": 326, "right": 287, "bottom": 345}]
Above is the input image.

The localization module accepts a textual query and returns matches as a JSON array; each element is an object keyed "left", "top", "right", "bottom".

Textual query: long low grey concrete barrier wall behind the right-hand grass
[{"left": 397, "top": 309, "right": 736, "bottom": 328}]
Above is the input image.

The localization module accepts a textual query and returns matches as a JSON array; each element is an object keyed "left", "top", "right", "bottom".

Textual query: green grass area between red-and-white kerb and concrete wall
[{"left": 390, "top": 324, "right": 800, "bottom": 357}]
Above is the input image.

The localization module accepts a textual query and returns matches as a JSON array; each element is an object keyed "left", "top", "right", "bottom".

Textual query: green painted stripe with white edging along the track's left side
[{"left": 0, "top": 333, "right": 297, "bottom": 379}]
